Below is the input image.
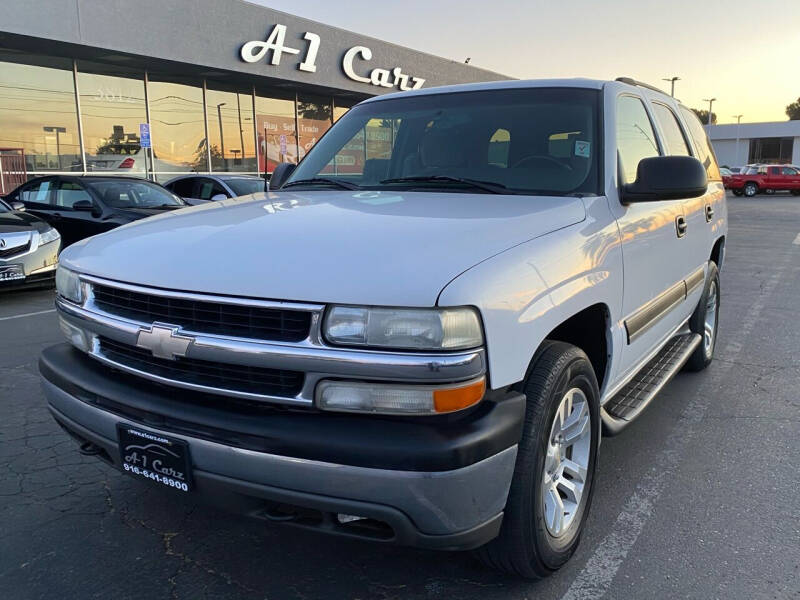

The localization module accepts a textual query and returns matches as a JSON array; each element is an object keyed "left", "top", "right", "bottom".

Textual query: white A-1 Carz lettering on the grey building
[{"left": 240, "top": 24, "right": 425, "bottom": 90}]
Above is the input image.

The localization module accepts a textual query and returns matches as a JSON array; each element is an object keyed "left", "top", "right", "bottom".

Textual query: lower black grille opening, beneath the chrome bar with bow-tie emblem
[{"left": 99, "top": 337, "right": 304, "bottom": 398}]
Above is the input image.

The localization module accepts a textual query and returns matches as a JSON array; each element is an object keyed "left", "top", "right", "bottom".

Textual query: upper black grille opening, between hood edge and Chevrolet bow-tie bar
[{"left": 93, "top": 284, "right": 311, "bottom": 342}]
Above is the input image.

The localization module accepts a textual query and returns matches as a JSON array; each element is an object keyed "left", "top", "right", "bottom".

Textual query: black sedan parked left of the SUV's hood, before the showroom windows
[{"left": 5, "top": 175, "right": 187, "bottom": 247}]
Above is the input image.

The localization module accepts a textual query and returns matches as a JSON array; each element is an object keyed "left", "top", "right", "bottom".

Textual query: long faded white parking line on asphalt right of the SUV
[{"left": 561, "top": 252, "right": 800, "bottom": 600}]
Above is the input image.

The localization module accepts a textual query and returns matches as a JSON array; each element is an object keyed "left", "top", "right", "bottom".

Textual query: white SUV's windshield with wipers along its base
[{"left": 284, "top": 88, "right": 600, "bottom": 195}]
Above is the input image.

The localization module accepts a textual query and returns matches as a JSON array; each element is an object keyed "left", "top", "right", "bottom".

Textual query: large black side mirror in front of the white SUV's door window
[{"left": 620, "top": 156, "right": 708, "bottom": 204}]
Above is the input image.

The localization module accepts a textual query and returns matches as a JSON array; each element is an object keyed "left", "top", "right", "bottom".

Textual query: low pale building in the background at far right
[{"left": 706, "top": 121, "right": 800, "bottom": 167}]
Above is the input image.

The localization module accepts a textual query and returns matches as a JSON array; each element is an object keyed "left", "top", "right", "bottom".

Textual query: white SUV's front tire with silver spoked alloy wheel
[{"left": 476, "top": 341, "right": 600, "bottom": 578}]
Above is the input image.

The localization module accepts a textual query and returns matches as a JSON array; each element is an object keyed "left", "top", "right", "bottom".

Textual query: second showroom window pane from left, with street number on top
[{"left": 78, "top": 62, "right": 147, "bottom": 175}]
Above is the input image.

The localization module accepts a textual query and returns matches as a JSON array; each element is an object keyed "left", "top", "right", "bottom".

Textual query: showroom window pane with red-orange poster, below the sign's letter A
[{"left": 256, "top": 91, "right": 297, "bottom": 173}]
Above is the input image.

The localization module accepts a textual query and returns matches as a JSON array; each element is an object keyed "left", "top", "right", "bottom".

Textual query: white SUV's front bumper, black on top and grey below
[{"left": 40, "top": 344, "right": 525, "bottom": 550}]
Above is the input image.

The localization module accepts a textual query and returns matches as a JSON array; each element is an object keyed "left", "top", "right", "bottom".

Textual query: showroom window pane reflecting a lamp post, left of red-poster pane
[{"left": 206, "top": 84, "right": 256, "bottom": 173}]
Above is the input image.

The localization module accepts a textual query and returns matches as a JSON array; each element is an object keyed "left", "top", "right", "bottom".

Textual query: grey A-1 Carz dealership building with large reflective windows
[{"left": 0, "top": 0, "right": 506, "bottom": 193}]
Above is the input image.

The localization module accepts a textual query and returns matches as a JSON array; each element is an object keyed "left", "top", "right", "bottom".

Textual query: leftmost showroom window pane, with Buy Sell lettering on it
[{"left": 0, "top": 53, "right": 82, "bottom": 172}]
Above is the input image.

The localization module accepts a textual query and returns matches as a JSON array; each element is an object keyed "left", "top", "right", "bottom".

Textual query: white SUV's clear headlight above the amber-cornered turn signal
[{"left": 323, "top": 306, "right": 483, "bottom": 350}]
